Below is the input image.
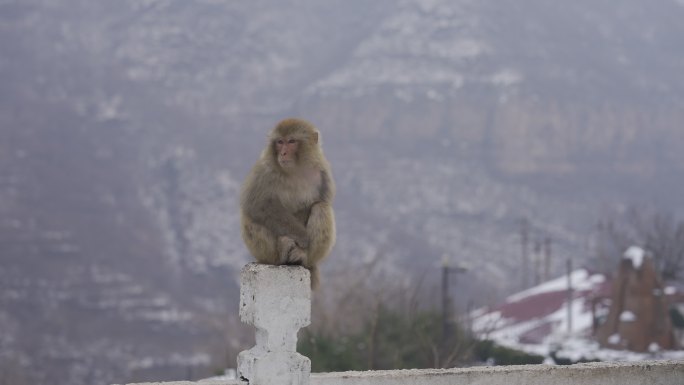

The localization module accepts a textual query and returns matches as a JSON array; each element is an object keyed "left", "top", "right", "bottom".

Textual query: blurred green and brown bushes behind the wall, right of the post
[{"left": 308, "top": 253, "right": 474, "bottom": 370}]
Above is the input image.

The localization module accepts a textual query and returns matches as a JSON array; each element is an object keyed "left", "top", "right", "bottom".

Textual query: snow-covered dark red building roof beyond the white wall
[{"left": 470, "top": 268, "right": 684, "bottom": 360}]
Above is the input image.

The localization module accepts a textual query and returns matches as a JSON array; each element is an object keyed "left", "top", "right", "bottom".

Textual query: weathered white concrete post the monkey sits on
[{"left": 237, "top": 263, "right": 311, "bottom": 385}]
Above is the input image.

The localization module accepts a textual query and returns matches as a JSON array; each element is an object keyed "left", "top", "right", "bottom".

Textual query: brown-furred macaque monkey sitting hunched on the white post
[{"left": 240, "top": 119, "right": 335, "bottom": 288}]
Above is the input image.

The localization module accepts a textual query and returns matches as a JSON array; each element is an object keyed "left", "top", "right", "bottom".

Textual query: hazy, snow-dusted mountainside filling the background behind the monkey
[{"left": 0, "top": 0, "right": 684, "bottom": 385}]
